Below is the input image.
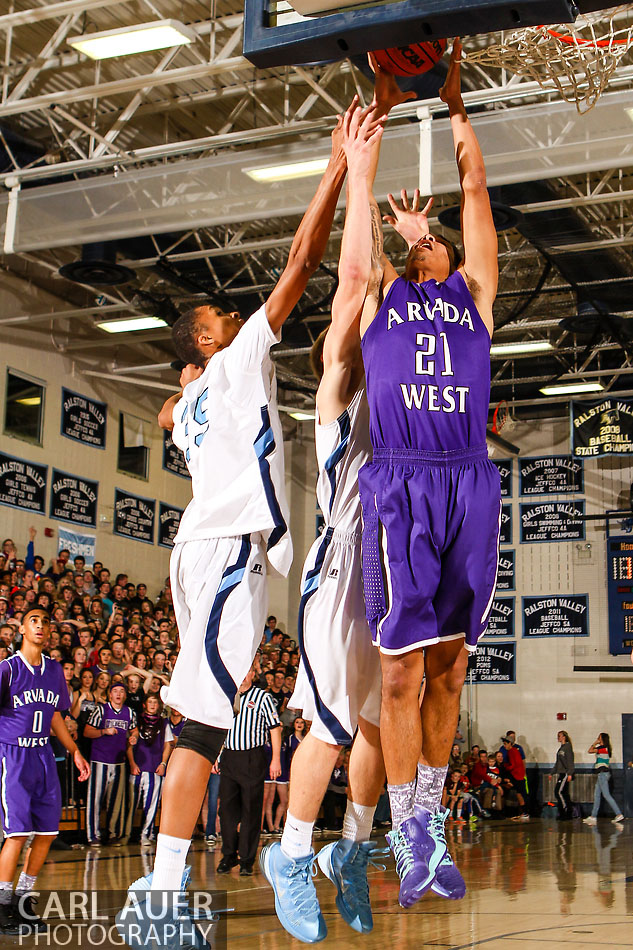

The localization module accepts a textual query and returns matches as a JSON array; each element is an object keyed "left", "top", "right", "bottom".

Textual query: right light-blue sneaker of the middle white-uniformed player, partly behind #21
[{"left": 317, "top": 838, "right": 386, "bottom": 934}]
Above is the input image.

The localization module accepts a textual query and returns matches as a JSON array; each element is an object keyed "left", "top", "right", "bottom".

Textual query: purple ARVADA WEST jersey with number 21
[{"left": 362, "top": 271, "right": 490, "bottom": 452}]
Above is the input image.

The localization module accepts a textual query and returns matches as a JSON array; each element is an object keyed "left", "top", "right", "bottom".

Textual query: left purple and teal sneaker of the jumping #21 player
[{"left": 387, "top": 809, "right": 448, "bottom": 907}]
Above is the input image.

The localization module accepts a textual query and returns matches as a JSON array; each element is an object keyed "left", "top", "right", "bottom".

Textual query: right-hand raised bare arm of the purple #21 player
[{"left": 440, "top": 39, "right": 499, "bottom": 335}]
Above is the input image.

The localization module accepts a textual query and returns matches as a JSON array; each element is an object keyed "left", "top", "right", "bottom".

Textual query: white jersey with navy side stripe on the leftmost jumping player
[{"left": 172, "top": 307, "right": 292, "bottom": 575}]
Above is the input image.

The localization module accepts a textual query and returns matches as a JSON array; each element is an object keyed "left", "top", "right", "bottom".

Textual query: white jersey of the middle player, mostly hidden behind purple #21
[{"left": 314, "top": 387, "right": 371, "bottom": 531}]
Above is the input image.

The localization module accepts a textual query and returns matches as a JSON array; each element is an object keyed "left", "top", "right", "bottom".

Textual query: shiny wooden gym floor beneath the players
[{"left": 9, "top": 819, "right": 633, "bottom": 950}]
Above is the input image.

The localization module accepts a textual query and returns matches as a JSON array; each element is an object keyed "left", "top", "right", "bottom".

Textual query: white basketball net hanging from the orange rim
[{"left": 462, "top": 4, "right": 633, "bottom": 113}]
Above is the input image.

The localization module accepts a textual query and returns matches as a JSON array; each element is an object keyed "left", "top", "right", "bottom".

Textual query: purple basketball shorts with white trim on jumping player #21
[{"left": 359, "top": 444, "right": 501, "bottom": 654}]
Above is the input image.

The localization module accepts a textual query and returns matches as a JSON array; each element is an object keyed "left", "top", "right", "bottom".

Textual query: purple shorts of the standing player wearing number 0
[{"left": 0, "top": 742, "right": 62, "bottom": 838}]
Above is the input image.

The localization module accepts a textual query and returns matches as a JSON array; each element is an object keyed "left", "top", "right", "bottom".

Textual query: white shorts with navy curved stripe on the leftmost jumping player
[{"left": 161, "top": 534, "right": 268, "bottom": 729}]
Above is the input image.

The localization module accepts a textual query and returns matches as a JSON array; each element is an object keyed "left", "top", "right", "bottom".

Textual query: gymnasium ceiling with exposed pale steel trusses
[{"left": 0, "top": 0, "right": 633, "bottom": 426}]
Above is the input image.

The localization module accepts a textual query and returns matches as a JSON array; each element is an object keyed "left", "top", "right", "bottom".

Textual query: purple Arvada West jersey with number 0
[{"left": 0, "top": 651, "right": 70, "bottom": 749}]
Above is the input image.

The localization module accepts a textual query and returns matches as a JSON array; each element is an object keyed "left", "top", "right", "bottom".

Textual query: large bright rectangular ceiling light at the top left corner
[{"left": 68, "top": 20, "right": 198, "bottom": 59}]
